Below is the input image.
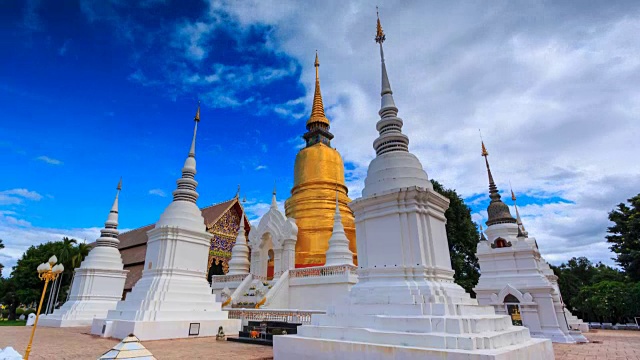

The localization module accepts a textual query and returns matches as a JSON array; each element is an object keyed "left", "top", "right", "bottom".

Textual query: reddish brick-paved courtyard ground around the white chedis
[{"left": 0, "top": 326, "right": 640, "bottom": 360}]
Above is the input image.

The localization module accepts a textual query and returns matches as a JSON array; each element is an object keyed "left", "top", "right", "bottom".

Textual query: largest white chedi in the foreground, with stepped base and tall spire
[{"left": 274, "top": 12, "right": 554, "bottom": 360}]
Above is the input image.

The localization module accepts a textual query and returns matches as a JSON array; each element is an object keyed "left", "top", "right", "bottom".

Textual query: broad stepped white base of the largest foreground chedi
[{"left": 274, "top": 282, "right": 553, "bottom": 360}]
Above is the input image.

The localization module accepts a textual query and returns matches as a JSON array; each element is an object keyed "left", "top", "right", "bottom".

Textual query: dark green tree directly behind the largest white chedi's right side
[{"left": 431, "top": 180, "right": 480, "bottom": 296}]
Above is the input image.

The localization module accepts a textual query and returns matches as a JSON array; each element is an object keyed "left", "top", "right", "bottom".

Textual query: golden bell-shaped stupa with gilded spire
[{"left": 284, "top": 53, "right": 356, "bottom": 268}]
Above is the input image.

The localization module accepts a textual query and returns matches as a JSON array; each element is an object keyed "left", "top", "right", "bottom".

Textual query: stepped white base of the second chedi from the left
[{"left": 91, "top": 270, "right": 241, "bottom": 341}]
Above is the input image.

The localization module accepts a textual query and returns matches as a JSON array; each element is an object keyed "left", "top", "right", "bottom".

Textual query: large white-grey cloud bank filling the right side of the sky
[{"left": 205, "top": 1, "right": 640, "bottom": 263}]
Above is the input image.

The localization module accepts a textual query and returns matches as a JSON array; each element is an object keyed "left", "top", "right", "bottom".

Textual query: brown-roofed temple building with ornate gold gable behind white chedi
[{"left": 118, "top": 194, "right": 251, "bottom": 298}]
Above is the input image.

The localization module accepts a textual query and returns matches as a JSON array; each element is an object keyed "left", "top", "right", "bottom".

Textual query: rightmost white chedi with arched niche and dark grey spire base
[{"left": 473, "top": 155, "right": 587, "bottom": 343}]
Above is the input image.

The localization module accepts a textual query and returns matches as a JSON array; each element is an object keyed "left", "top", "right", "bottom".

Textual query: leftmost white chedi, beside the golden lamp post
[{"left": 38, "top": 179, "right": 129, "bottom": 327}]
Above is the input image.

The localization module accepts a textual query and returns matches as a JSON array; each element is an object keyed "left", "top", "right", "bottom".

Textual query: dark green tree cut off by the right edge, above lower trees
[{"left": 607, "top": 194, "right": 640, "bottom": 281}]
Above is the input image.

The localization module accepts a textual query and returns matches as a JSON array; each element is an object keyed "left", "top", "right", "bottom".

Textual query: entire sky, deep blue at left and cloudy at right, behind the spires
[{"left": 0, "top": 0, "right": 640, "bottom": 275}]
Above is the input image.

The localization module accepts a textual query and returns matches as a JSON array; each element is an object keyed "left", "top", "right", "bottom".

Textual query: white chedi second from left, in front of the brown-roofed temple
[{"left": 91, "top": 106, "right": 240, "bottom": 341}]
